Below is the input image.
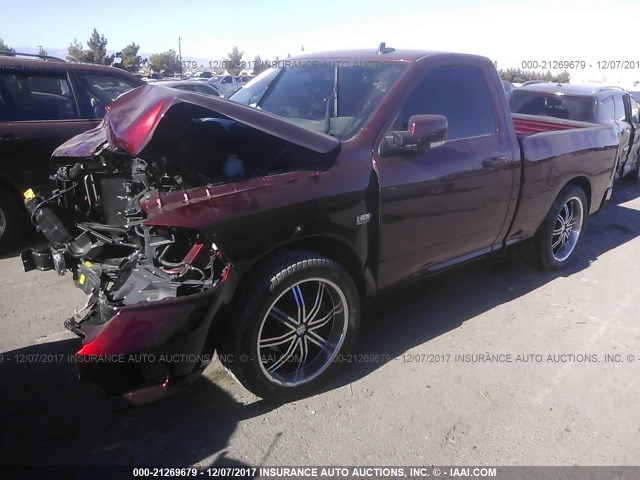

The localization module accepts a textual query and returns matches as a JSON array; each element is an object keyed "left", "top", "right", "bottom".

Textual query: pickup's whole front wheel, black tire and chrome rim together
[{"left": 218, "top": 249, "right": 360, "bottom": 402}]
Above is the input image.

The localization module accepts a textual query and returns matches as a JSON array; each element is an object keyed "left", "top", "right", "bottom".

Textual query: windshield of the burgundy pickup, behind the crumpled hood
[{"left": 230, "top": 61, "right": 405, "bottom": 140}]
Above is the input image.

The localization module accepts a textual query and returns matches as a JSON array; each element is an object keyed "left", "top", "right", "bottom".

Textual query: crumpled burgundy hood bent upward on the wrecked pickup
[{"left": 53, "top": 85, "right": 340, "bottom": 157}]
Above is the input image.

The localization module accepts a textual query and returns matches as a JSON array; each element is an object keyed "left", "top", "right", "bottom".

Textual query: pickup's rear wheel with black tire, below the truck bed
[{"left": 521, "top": 184, "right": 589, "bottom": 270}]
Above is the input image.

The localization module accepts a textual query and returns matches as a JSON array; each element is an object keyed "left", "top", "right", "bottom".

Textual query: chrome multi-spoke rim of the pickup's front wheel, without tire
[{"left": 256, "top": 278, "right": 349, "bottom": 387}]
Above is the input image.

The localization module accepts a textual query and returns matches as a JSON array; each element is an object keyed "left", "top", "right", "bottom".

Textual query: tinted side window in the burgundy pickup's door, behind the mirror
[{"left": 393, "top": 66, "right": 496, "bottom": 140}]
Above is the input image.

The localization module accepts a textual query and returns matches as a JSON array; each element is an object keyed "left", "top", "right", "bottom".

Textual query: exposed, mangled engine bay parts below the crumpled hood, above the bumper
[{"left": 22, "top": 148, "right": 228, "bottom": 336}]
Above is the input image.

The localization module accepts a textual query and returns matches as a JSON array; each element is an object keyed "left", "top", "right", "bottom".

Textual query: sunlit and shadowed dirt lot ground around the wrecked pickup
[{"left": 0, "top": 184, "right": 640, "bottom": 466}]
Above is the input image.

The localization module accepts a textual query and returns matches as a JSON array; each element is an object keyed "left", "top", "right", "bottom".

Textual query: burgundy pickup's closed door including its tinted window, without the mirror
[{"left": 375, "top": 66, "right": 520, "bottom": 288}]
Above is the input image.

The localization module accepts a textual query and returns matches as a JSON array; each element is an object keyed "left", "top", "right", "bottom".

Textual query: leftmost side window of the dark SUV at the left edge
[{"left": 0, "top": 73, "right": 78, "bottom": 121}]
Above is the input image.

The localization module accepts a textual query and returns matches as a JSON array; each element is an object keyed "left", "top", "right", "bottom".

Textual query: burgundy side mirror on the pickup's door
[{"left": 379, "top": 115, "right": 447, "bottom": 157}]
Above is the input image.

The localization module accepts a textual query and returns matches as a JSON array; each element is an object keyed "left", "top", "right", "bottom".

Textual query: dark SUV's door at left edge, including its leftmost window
[{"left": 0, "top": 70, "right": 92, "bottom": 193}]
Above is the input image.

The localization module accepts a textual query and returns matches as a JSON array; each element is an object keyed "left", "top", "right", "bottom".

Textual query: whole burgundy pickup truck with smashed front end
[{"left": 22, "top": 45, "right": 618, "bottom": 404}]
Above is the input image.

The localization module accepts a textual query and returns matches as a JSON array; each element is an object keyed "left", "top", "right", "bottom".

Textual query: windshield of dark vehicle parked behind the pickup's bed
[{"left": 509, "top": 89, "right": 596, "bottom": 122}]
